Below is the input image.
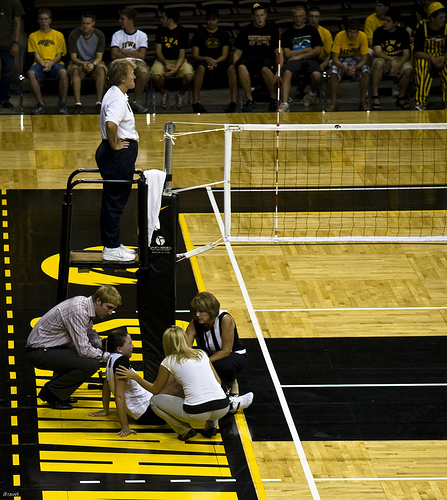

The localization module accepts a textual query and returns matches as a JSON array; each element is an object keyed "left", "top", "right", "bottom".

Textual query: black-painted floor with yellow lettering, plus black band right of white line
[{"left": 0, "top": 190, "right": 447, "bottom": 500}]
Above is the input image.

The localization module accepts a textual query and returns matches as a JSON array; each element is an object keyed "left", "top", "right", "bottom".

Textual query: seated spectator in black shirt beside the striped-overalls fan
[{"left": 371, "top": 9, "right": 413, "bottom": 110}]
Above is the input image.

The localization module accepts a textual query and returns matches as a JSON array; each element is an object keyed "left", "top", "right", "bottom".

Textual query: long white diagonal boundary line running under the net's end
[{"left": 207, "top": 187, "right": 321, "bottom": 500}]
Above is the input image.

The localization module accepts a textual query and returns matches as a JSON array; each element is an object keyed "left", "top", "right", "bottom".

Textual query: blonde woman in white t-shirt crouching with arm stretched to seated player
[{"left": 116, "top": 326, "right": 230, "bottom": 441}]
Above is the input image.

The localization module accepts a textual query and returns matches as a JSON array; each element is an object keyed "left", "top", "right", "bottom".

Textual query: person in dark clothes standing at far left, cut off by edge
[{"left": 0, "top": 0, "right": 25, "bottom": 109}]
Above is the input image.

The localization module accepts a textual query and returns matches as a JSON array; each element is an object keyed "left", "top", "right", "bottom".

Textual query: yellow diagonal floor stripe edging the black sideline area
[{"left": 179, "top": 214, "right": 267, "bottom": 500}]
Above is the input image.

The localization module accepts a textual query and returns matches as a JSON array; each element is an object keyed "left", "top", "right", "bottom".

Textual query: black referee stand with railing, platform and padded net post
[{"left": 57, "top": 169, "right": 178, "bottom": 380}]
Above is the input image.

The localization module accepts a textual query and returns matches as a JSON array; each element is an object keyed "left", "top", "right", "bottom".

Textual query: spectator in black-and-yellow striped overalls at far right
[{"left": 413, "top": 2, "right": 447, "bottom": 111}]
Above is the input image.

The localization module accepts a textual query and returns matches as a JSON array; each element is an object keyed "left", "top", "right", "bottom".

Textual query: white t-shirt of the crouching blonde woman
[{"left": 161, "top": 351, "right": 226, "bottom": 406}]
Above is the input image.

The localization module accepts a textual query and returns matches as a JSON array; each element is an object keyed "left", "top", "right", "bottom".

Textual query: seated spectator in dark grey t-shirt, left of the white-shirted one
[{"left": 67, "top": 12, "right": 107, "bottom": 115}]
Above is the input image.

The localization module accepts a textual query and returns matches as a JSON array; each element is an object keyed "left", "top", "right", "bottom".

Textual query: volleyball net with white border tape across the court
[{"left": 224, "top": 123, "right": 447, "bottom": 243}]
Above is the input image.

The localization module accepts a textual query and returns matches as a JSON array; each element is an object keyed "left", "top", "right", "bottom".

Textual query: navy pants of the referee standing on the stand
[{"left": 96, "top": 140, "right": 138, "bottom": 248}]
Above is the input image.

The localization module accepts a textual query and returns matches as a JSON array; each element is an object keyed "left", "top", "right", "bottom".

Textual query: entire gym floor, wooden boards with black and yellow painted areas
[{"left": 0, "top": 111, "right": 447, "bottom": 500}]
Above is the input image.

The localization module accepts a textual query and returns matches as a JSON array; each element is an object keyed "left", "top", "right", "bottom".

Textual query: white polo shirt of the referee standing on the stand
[{"left": 99, "top": 85, "right": 139, "bottom": 141}]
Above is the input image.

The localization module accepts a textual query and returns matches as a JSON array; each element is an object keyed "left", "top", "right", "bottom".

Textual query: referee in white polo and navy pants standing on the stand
[{"left": 96, "top": 59, "right": 138, "bottom": 262}]
